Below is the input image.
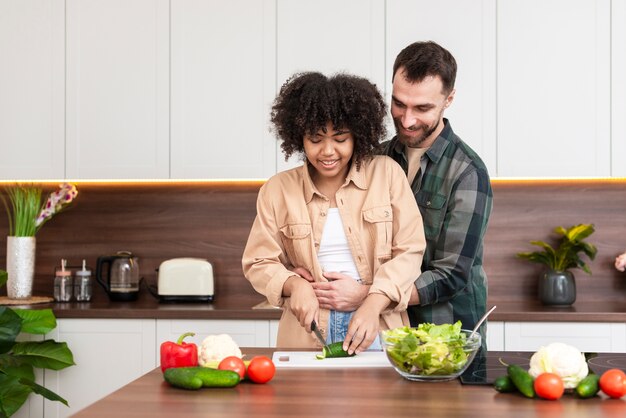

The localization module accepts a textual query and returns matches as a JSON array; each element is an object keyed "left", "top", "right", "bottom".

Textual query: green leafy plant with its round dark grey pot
[{"left": 517, "top": 224, "right": 598, "bottom": 305}]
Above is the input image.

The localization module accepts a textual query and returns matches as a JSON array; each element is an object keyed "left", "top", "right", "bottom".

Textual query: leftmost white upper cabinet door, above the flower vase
[{"left": 0, "top": 0, "right": 65, "bottom": 179}]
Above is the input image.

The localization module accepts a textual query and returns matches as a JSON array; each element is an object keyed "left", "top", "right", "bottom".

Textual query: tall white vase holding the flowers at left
[{"left": 7, "top": 237, "right": 37, "bottom": 299}]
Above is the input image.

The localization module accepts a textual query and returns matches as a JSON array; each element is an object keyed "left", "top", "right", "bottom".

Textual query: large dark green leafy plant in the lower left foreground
[{"left": 0, "top": 270, "right": 75, "bottom": 418}]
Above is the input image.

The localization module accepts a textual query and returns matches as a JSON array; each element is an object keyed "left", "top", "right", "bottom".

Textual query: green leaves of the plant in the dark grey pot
[{"left": 517, "top": 224, "right": 598, "bottom": 274}]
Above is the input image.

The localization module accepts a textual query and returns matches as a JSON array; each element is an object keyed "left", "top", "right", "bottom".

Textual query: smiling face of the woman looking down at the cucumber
[{"left": 304, "top": 122, "right": 354, "bottom": 180}]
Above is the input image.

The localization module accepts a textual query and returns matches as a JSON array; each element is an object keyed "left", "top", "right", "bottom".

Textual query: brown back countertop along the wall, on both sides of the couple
[{"left": 4, "top": 292, "right": 626, "bottom": 322}]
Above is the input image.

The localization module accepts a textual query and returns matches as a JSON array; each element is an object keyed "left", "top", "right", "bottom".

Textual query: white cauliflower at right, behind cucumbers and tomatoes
[{"left": 528, "top": 343, "right": 589, "bottom": 389}]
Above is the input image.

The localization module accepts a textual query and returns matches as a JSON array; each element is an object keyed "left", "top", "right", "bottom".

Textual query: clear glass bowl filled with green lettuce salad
[{"left": 380, "top": 321, "right": 481, "bottom": 381}]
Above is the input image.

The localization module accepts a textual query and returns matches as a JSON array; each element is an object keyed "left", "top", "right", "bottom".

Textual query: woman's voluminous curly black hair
[{"left": 271, "top": 72, "right": 387, "bottom": 168}]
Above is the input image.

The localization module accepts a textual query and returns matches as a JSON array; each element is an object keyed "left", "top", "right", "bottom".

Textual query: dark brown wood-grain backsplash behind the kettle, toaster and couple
[{"left": 0, "top": 180, "right": 626, "bottom": 303}]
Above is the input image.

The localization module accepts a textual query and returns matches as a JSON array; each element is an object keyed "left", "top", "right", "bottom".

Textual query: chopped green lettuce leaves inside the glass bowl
[{"left": 383, "top": 321, "right": 471, "bottom": 376}]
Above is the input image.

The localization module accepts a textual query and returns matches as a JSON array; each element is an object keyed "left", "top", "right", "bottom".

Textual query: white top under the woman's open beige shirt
[{"left": 317, "top": 208, "right": 361, "bottom": 281}]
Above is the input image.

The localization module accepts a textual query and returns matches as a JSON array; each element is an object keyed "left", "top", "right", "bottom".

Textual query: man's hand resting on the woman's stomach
[{"left": 312, "top": 272, "right": 370, "bottom": 312}]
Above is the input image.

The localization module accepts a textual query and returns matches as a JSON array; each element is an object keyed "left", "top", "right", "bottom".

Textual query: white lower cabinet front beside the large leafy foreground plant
[{"left": 44, "top": 319, "right": 157, "bottom": 418}]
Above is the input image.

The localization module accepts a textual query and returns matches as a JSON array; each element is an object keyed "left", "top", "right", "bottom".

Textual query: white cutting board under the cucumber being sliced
[{"left": 272, "top": 350, "right": 391, "bottom": 369}]
